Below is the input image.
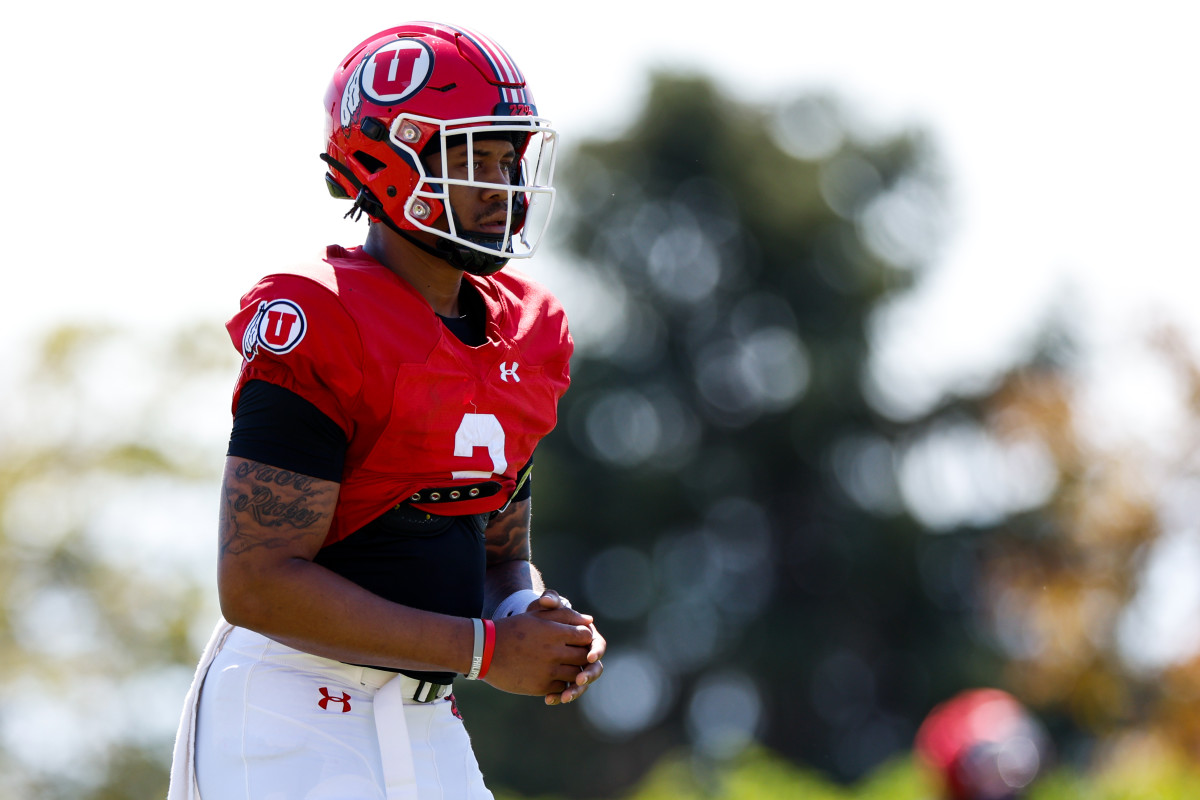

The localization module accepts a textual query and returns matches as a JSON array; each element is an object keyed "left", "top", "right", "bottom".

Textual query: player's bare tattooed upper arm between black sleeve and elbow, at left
[{"left": 220, "top": 456, "right": 340, "bottom": 573}]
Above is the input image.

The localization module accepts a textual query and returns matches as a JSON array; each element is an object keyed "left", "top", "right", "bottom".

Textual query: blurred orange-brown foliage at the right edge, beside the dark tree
[{"left": 969, "top": 326, "right": 1200, "bottom": 759}]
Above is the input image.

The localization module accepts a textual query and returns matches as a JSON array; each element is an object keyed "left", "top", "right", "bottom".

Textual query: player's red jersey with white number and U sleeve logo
[{"left": 226, "top": 246, "right": 574, "bottom": 545}]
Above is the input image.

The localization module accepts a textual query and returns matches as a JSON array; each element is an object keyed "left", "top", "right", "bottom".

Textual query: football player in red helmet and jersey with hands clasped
[{"left": 170, "top": 23, "right": 605, "bottom": 800}]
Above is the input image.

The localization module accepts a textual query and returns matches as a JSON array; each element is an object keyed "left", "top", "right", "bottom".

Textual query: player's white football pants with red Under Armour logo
[{"left": 178, "top": 627, "right": 492, "bottom": 800}]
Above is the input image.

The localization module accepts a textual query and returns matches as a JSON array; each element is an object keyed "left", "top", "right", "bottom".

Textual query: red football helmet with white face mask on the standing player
[{"left": 322, "top": 23, "right": 557, "bottom": 275}]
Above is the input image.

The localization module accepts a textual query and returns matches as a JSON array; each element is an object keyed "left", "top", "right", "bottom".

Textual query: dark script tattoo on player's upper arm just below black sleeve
[{"left": 221, "top": 462, "right": 336, "bottom": 554}]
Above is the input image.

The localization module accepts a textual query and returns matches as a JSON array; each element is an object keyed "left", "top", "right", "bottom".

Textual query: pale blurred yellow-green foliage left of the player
[{"left": 0, "top": 327, "right": 236, "bottom": 800}]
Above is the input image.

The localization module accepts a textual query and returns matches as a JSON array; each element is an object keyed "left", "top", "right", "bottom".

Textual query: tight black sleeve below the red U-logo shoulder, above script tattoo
[{"left": 228, "top": 380, "right": 347, "bottom": 482}]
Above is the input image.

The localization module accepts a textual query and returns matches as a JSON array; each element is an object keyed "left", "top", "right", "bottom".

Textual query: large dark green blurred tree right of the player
[{"left": 460, "top": 74, "right": 1046, "bottom": 794}]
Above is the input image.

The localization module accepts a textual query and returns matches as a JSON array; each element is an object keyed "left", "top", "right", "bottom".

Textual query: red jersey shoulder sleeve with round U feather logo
[{"left": 226, "top": 275, "right": 362, "bottom": 439}]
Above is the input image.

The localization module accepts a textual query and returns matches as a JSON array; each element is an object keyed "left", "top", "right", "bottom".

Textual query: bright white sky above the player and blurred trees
[{"left": 0, "top": 0, "right": 1200, "bottom": 412}]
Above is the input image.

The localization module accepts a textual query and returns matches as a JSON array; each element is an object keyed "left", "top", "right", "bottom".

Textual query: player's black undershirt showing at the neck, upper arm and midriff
[{"left": 228, "top": 282, "right": 533, "bottom": 684}]
